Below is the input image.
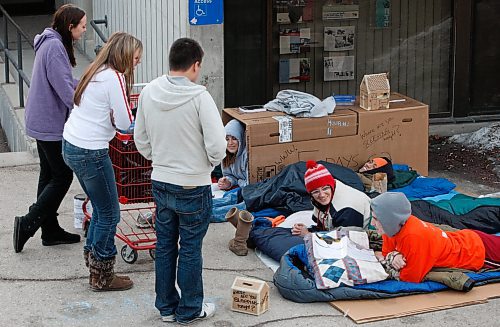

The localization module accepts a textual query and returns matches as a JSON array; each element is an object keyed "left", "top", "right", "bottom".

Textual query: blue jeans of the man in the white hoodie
[{"left": 152, "top": 181, "right": 212, "bottom": 321}]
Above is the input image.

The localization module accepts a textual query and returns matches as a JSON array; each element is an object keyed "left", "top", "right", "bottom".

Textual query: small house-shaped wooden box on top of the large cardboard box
[{"left": 359, "top": 73, "right": 391, "bottom": 110}]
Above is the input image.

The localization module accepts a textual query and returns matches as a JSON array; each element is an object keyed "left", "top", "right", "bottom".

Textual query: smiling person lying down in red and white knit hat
[{"left": 292, "top": 160, "right": 370, "bottom": 236}]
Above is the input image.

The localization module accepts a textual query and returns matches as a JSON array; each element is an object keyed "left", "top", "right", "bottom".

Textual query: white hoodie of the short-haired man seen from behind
[{"left": 134, "top": 75, "right": 227, "bottom": 186}]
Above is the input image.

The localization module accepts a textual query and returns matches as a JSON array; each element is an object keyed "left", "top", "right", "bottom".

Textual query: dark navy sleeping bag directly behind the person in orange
[{"left": 411, "top": 200, "right": 500, "bottom": 234}]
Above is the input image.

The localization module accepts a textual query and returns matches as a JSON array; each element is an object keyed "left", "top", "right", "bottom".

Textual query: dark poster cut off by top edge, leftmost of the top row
[{"left": 274, "top": 0, "right": 314, "bottom": 24}]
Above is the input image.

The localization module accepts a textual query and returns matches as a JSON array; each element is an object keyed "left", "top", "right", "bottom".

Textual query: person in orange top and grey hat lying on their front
[{"left": 371, "top": 192, "right": 500, "bottom": 283}]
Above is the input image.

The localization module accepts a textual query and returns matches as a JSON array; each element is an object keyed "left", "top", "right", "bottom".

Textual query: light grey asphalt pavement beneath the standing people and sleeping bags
[{"left": 0, "top": 158, "right": 500, "bottom": 327}]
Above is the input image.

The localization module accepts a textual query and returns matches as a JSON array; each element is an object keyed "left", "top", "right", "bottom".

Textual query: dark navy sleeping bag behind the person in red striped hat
[{"left": 241, "top": 161, "right": 364, "bottom": 215}]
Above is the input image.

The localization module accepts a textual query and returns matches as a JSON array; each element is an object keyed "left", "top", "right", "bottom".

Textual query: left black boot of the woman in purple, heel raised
[{"left": 13, "top": 204, "right": 45, "bottom": 253}]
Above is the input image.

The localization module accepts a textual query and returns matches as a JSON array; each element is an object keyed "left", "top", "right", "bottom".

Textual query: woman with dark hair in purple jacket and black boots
[{"left": 13, "top": 5, "right": 87, "bottom": 252}]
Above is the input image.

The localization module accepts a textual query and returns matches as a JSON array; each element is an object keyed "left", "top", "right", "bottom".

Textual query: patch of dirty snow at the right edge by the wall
[{"left": 449, "top": 122, "right": 500, "bottom": 150}]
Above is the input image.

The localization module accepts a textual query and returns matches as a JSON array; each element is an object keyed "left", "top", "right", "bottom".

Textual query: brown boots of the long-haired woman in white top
[{"left": 89, "top": 253, "right": 134, "bottom": 292}]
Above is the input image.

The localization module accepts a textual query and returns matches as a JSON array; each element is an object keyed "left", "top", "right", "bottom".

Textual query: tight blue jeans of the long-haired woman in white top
[{"left": 63, "top": 140, "right": 120, "bottom": 260}]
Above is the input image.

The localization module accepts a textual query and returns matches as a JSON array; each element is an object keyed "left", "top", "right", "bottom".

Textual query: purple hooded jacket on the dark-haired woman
[{"left": 25, "top": 28, "right": 77, "bottom": 141}]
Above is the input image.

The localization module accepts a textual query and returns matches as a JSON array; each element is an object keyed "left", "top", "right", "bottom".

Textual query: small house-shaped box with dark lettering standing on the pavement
[{"left": 231, "top": 277, "right": 269, "bottom": 316}]
